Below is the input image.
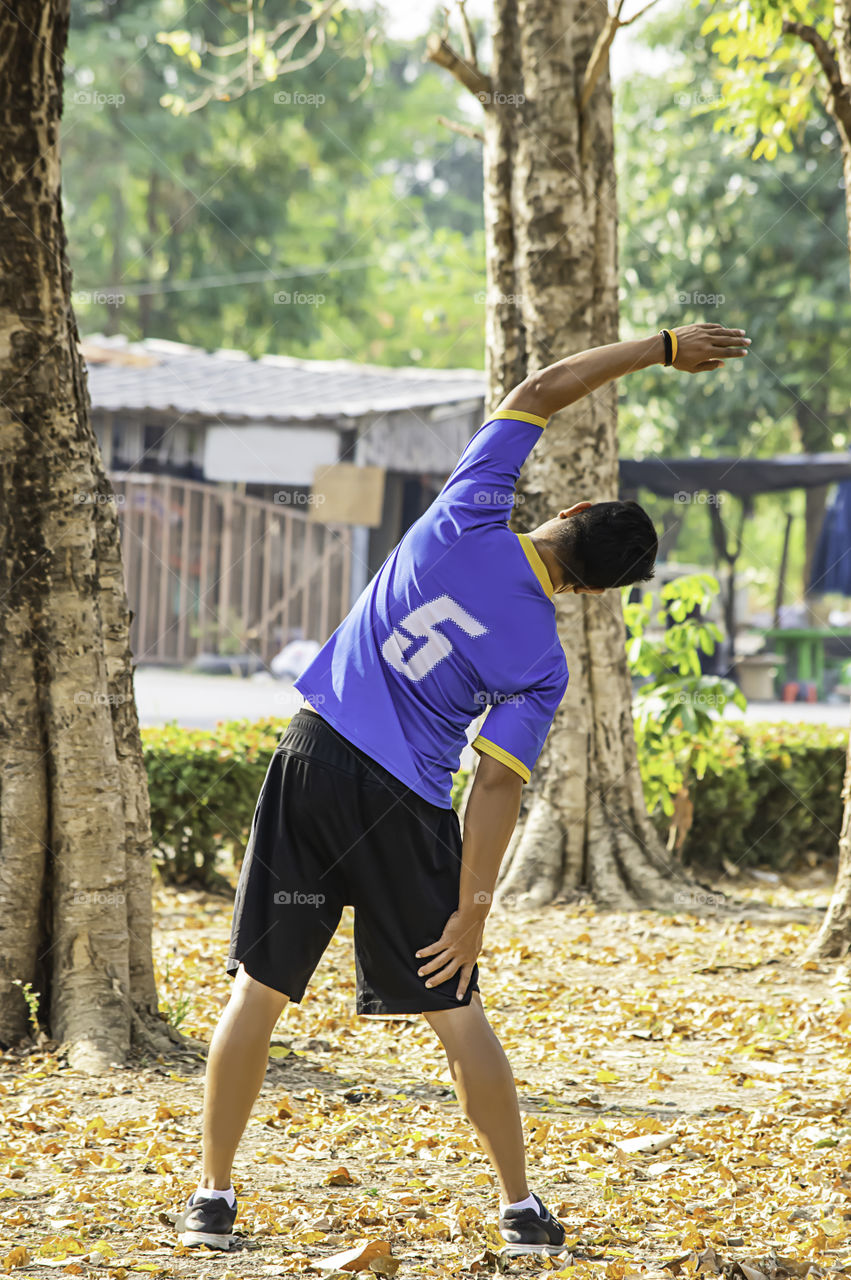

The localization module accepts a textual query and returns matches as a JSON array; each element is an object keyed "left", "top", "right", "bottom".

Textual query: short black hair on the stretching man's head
[{"left": 553, "top": 502, "right": 659, "bottom": 588}]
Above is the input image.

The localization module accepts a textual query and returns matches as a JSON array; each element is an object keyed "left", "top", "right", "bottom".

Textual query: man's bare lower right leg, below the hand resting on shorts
[{"left": 424, "top": 991, "right": 529, "bottom": 1204}]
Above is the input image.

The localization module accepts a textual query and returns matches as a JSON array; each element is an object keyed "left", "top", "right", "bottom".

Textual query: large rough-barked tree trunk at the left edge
[{"left": 0, "top": 0, "right": 162, "bottom": 1071}]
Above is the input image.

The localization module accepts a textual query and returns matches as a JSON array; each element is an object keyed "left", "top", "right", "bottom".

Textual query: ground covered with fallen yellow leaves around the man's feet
[{"left": 0, "top": 872, "right": 851, "bottom": 1280}]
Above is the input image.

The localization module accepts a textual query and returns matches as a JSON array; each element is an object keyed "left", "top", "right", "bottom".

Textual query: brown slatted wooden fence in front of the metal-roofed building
[{"left": 111, "top": 472, "right": 352, "bottom": 663}]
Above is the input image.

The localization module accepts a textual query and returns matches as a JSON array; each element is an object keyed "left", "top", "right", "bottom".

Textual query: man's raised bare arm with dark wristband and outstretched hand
[{"left": 499, "top": 324, "right": 750, "bottom": 417}]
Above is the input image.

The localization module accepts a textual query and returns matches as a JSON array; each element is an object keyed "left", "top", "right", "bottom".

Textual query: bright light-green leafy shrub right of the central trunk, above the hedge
[{"left": 623, "top": 573, "right": 746, "bottom": 817}]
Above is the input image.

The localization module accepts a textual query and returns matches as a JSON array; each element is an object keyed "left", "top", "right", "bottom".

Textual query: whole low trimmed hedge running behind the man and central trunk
[{"left": 142, "top": 718, "right": 848, "bottom": 886}]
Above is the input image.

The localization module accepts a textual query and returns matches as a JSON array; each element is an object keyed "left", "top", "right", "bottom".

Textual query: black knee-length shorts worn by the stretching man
[{"left": 227, "top": 710, "right": 479, "bottom": 1014}]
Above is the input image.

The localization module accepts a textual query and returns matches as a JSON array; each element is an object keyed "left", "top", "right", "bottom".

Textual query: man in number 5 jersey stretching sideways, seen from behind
[{"left": 178, "top": 324, "right": 750, "bottom": 1253}]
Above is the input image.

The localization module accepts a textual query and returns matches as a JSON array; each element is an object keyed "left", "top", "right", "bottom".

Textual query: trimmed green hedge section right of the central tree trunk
[{"left": 655, "top": 723, "right": 848, "bottom": 868}]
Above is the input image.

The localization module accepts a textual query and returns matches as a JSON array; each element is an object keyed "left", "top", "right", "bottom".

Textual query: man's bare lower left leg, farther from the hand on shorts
[{"left": 198, "top": 965, "right": 288, "bottom": 1190}]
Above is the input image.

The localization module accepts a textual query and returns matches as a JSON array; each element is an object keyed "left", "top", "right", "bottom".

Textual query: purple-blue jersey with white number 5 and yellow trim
[{"left": 296, "top": 410, "right": 567, "bottom": 808}]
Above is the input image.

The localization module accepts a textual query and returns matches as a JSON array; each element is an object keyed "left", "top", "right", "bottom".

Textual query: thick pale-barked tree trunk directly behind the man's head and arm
[{"left": 473, "top": 0, "right": 687, "bottom": 906}]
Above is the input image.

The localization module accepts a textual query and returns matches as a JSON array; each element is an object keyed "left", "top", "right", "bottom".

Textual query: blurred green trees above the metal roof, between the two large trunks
[{"left": 63, "top": 0, "right": 485, "bottom": 367}]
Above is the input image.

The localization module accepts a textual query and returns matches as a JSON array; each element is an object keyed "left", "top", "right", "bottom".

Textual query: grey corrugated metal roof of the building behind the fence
[{"left": 82, "top": 334, "right": 485, "bottom": 422}]
